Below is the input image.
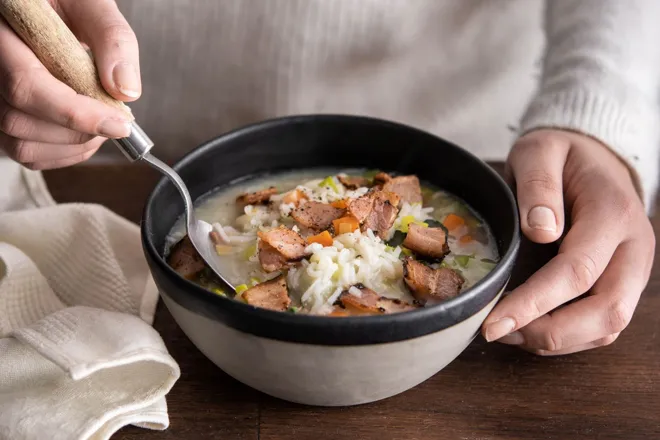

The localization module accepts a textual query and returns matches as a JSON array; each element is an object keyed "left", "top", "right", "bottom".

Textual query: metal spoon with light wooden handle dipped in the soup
[{"left": 0, "top": 0, "right": 236, "bottom": 293}]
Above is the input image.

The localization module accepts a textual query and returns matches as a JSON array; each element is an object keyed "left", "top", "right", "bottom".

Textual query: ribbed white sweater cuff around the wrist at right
[{"left": 520, "top": 88, "right": 660, "bottom": 214}]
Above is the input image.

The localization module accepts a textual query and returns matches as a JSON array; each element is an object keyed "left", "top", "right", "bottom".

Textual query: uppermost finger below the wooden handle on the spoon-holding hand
[{"left": 0, "top": 19, "right": 131, "bottom": 138}]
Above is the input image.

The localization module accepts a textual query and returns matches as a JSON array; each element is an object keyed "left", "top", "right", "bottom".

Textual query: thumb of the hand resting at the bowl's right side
[{"left": 508, "top": 130, "right": 570, "bottom": 243}]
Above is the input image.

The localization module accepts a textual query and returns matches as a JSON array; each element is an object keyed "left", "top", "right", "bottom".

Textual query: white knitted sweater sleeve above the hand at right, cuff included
[{"left": 521, "top": 0, "right": 660, "bottom": 212}]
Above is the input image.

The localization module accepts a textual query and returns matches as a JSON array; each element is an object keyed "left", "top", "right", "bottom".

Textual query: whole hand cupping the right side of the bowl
[{"left": 483, "top": 130, "right": 655, "bottom": 355}]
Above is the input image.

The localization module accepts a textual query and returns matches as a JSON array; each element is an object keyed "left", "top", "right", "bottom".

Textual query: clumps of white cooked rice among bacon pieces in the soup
[{"left": 213, "top": 177, "right": 433, "bottom": 314}]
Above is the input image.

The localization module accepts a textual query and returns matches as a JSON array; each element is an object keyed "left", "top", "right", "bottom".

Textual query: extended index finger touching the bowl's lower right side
[{"left": 483, "top": 182, "right": 625, "bottom": 341}]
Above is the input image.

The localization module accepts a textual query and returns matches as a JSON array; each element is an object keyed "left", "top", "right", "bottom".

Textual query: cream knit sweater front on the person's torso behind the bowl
[{"left": 103, "top": 0, "right": 543, "bottom": 160}]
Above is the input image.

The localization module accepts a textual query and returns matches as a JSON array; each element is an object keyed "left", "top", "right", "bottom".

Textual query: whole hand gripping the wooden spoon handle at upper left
[{"left": 0, "top": 0, "right": 141, "bottom": 170}]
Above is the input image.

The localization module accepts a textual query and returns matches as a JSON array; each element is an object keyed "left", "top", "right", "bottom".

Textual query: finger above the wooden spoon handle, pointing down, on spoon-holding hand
[{"left": 60, "top": 0, "right": 142, "bottom": 101}]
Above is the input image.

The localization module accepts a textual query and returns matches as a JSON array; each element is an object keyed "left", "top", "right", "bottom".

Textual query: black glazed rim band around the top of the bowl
[{"left": 140, "top": 114, "right": 521, "bottom": 345}]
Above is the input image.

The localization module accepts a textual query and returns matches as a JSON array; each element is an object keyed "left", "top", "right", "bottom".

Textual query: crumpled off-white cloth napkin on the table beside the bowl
[{"left": 0, "top": 159, "right": 180, "bottom": 440}]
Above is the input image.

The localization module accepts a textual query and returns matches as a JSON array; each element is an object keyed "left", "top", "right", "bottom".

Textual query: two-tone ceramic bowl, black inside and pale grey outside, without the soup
[{"left": 141, "top": 115, "right": 520, "bottom": 406}]
